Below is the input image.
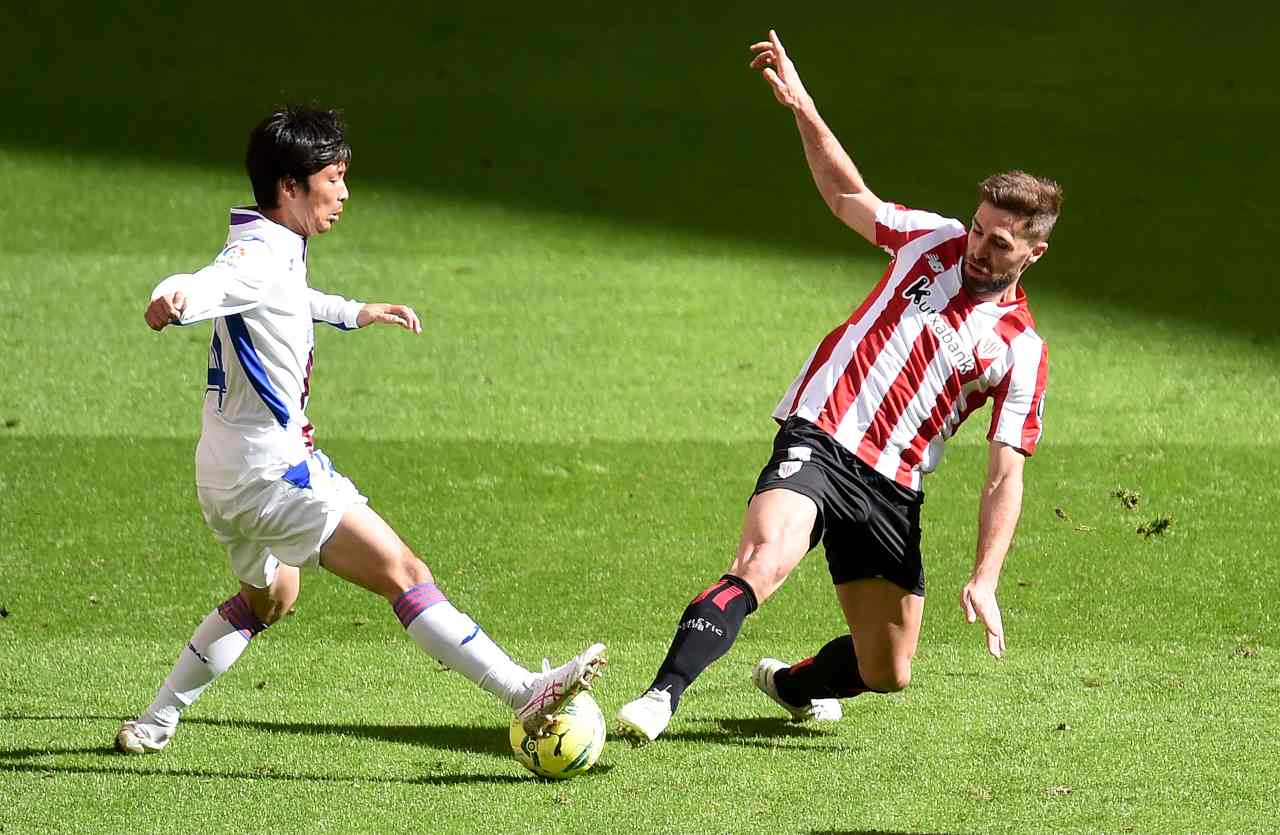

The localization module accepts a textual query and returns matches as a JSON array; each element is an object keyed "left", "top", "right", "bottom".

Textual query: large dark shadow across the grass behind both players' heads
[{"left": 10, "top": 6, "right": 1276, "bottom": 343}]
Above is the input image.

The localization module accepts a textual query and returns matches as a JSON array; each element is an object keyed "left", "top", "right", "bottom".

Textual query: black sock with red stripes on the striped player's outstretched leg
[{"left": 652, "top": 574, "right": 756, "bottom": 711}]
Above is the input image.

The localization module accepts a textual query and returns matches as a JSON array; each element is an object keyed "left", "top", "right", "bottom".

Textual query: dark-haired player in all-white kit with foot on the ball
[{"left": 115, "top": 108, "right": 604, "bottom": 753}]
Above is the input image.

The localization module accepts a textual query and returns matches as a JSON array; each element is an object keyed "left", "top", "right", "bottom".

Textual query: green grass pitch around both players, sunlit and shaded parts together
[{"left": 0, "top": 3, "right": 1280, "bottom": 835}]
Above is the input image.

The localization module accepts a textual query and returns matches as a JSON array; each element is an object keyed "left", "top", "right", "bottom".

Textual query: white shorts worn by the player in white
[{"left": 196, "top": 450, "right": 369, "bottom": 589}]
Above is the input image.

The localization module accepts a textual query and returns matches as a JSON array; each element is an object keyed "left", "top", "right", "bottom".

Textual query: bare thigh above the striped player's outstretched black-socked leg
[{"left": 730, "top": 488, "right": 818, "bottom": 602}]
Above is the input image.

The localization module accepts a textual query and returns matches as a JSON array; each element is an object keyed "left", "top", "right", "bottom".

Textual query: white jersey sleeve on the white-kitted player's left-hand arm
[{"left": 151, "top": 239, "right": 271, "bottom": 325}]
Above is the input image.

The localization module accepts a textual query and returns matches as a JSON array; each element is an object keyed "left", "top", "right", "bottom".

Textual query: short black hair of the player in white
[{"left": 244, "top": 105, "right": 351, "bottom": 209}]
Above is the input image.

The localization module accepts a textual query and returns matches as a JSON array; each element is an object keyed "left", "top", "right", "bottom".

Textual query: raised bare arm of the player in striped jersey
[{"left": 751, "top": 29, "right": 882, "bottom": 243}]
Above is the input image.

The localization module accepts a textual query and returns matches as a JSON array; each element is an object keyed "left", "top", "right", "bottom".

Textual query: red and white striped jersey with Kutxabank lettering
[{"left": 773, "top": 204, "right": 1048, "bottom": 490}]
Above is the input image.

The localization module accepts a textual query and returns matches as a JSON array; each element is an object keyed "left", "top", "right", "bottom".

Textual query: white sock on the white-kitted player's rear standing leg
[{"left": 142, "top": 594, "right": 266, "bottom": 727}]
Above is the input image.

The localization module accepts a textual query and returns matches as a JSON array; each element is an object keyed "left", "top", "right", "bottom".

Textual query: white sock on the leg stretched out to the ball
[{"left": 394, "top": 583, "right": 532, "bottom": 709}]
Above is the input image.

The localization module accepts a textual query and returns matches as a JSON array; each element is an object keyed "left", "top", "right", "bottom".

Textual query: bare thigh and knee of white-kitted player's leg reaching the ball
[{"left": 320, "top": 505, "right": 433, "bottom": 601}]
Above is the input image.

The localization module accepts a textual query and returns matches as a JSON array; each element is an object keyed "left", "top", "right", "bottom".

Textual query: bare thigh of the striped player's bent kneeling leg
[{"left": 836, "top": 578, "right": 924, "bottom": 692}]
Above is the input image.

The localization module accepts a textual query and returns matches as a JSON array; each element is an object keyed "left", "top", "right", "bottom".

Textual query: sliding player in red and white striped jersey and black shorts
[{"left": 618, "top": 32, "right": 1061, "bottom": 740}]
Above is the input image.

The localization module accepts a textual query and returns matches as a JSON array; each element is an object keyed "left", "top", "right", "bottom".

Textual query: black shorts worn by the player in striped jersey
[{"left": 751, "top": 418, "right": 924, "bottom": 597}]
